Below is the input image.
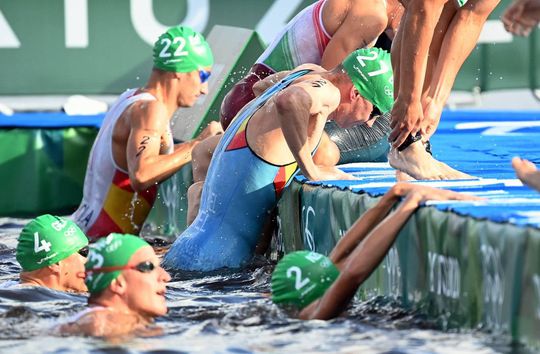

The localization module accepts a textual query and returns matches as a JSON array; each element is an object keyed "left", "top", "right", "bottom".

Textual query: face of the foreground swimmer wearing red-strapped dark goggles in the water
[{"left": 122, "top": 247, "right": 171, "bottom": 318}]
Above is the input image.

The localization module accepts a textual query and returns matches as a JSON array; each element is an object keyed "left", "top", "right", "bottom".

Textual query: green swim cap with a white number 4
[{"left": 16, "top": 214, "right": 88, "bottom": 272}]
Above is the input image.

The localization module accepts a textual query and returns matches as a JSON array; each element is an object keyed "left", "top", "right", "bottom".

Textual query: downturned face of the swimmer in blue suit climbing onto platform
[{"left": 333, "top": 88, "right": 373, "bottom": 128}]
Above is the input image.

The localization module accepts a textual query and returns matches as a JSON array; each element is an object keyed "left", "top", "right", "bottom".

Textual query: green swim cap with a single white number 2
[{"left": 272, "top": 251, "right": 339, "bottom": 309}]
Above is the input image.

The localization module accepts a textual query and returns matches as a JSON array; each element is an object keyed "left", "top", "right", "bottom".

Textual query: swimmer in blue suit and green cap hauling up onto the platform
[{"left": 163, "top": 48, "right": 392, "bottom": 271}]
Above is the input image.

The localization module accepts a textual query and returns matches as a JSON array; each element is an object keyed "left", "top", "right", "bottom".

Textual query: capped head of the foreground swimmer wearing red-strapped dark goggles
[{"left": 85, "top": 233, "right": 170, "bottom": 317}]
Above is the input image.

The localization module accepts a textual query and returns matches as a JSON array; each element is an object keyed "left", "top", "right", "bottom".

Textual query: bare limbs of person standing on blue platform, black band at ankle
[{"left": 388, "top": 0, "right": 500, "bottom": 179}]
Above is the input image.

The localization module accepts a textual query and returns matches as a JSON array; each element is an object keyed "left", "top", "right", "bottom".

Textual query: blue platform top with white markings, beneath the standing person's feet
[{"left": 296, "top": 111, "right": 540, "bottom": 227}]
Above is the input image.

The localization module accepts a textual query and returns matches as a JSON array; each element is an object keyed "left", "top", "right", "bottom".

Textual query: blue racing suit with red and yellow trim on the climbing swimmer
[{"left": 164, "top": 70, "right": 310, "bottom": 271}]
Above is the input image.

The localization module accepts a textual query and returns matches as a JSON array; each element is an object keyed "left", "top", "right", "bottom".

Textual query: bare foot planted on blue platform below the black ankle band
[{"left": 388, "top": 141, "right": 473, "bottom": 180}]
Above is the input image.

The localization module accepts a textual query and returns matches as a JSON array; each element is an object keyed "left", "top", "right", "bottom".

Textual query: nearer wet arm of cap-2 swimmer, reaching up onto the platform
[{"left": 300, "top": 184, "right": 480, "bottom": 320}]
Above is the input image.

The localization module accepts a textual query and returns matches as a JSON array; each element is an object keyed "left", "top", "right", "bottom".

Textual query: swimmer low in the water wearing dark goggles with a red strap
[{"left": 59, "top": 233, "right": 171, "bottom": 337}]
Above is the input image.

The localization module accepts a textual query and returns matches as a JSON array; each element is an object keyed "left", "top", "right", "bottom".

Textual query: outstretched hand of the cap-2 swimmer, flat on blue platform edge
[{"left": 392, "top": 182, "right": 484, "bottom": 204}]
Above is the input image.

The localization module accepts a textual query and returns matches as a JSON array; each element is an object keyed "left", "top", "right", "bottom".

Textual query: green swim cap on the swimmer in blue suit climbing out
[{"left": 341, "top": 48, "right": 394, "bottom": 113}]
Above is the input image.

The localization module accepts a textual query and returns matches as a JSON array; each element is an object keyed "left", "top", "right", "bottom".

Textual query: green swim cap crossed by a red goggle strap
[{"left": 84, "top": 233, "right": 150, "bottom": 294}]
